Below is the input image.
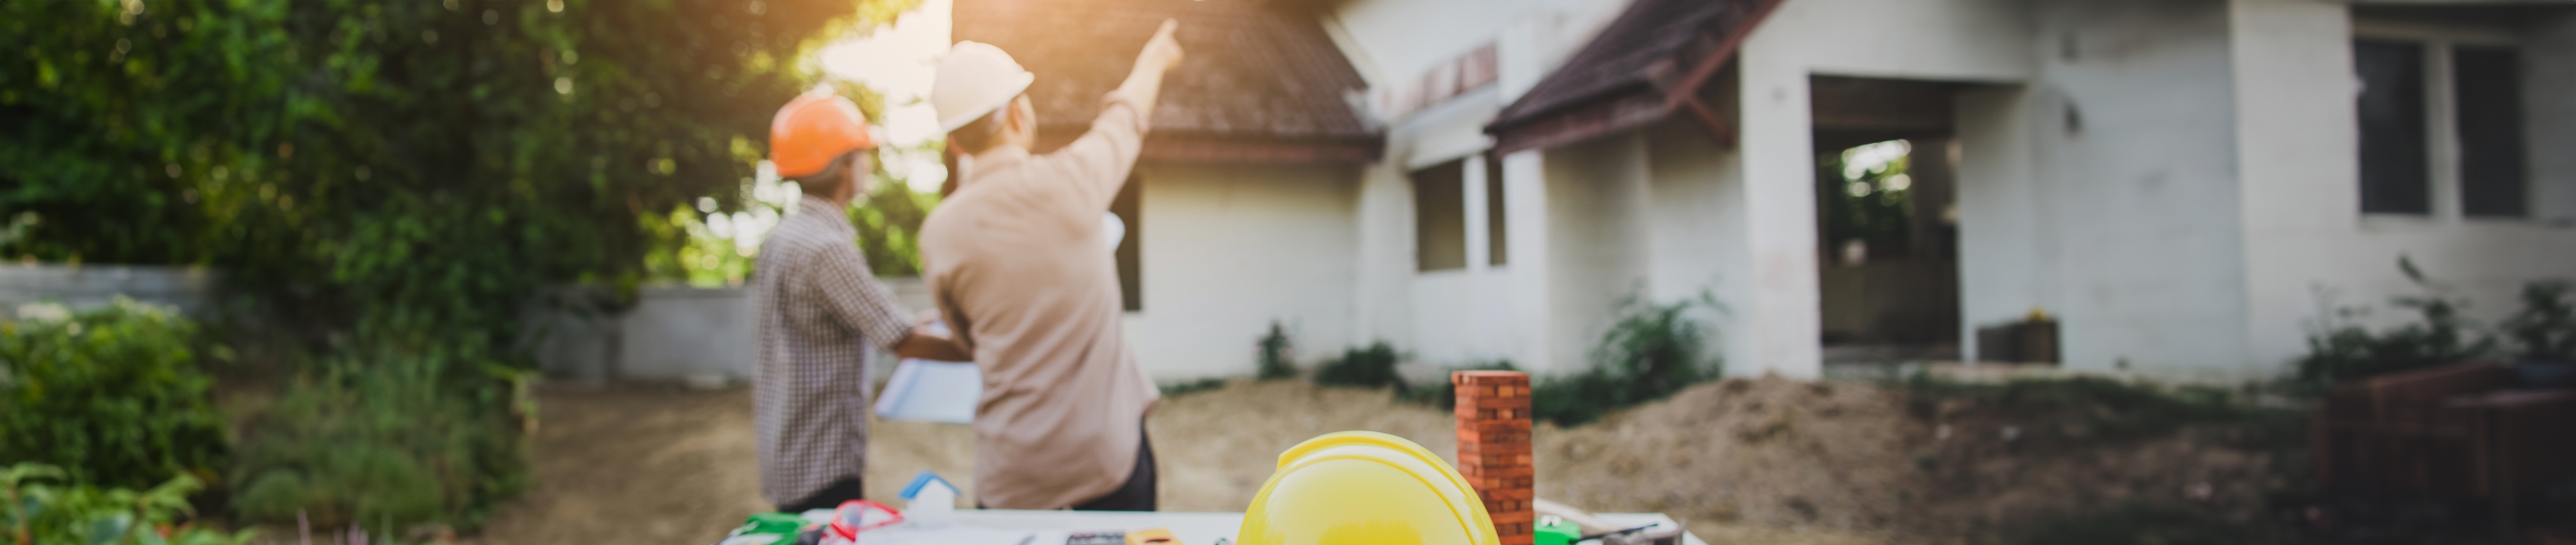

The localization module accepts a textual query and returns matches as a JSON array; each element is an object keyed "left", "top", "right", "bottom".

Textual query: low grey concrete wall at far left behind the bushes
[{"left": 0, "top": 265, "right": 222, "bottom": 319}]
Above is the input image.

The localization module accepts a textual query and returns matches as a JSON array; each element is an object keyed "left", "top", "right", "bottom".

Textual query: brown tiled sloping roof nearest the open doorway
[{"left": 1489, "top": 0, "right": 1780, "bottom": 151}]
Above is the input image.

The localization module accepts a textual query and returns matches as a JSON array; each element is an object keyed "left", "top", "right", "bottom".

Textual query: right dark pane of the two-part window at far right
[{"left": 2450, "top": 47, "right": 2529, "bottom": 216}]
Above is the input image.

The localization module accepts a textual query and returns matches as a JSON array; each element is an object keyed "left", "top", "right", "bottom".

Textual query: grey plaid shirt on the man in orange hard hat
[{"left": 752, "top": 195, "right": 912, "bottom": 503}]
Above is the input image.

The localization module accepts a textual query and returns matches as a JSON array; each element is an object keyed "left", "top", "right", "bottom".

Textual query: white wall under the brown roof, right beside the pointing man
[{"left": 1126, "top": 164, "right": 1365, "bottom": 381}]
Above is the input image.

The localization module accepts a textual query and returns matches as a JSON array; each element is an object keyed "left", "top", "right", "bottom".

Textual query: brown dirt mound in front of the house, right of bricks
[{"left": 1536, "top": 378, "right": 2272, "bottom": 540}]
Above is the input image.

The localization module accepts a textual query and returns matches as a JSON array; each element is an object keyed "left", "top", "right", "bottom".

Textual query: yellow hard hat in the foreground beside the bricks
[{"left": 1234, "top": 432, "right": 1499, "bottom": 545}]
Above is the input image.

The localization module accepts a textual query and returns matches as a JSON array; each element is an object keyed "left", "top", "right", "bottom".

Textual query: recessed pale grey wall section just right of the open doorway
[{"left": 2029, "top": 3, "right": 2246, "bottom": 373}]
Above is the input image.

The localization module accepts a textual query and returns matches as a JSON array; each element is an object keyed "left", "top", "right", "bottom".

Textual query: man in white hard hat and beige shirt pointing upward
[{"left": 919, "top": 21, "right": 1180, "bottom": 511}]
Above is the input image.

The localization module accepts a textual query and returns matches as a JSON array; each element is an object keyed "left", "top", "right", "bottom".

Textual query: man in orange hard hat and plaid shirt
[{"left": 752, "top": 92, "right": 966, "bottom": 511}]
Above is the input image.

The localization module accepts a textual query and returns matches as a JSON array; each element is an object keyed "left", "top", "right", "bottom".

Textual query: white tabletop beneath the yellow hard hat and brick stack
[{"left": 860, "top": 509, "right": 1708, "bottom": 545}]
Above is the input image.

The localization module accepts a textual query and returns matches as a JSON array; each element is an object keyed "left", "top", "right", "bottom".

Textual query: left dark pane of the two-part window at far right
[{"left": 2352, "top": 39, "right": 2431, "bottom": 213}]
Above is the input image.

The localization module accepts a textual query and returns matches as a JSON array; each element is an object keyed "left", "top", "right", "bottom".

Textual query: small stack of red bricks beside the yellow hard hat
[{"left": 1450, "top": 371, "right": 1538, "bottom": 545}]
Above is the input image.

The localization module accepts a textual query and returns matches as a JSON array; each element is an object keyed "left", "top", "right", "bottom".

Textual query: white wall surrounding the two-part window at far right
[{"left": 2231, "top": 0, "right": 2576, "bottom": 373}]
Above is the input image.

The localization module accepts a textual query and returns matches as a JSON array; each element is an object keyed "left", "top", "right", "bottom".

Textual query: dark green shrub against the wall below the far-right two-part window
[{"left": 2298, "top": 257, "right": 2496, "bottom": 385}]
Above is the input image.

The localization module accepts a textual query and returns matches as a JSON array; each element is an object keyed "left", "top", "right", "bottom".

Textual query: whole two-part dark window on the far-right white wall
[{"left": 2352, "top": 36, "right": 2529, "bottom": 216}]
